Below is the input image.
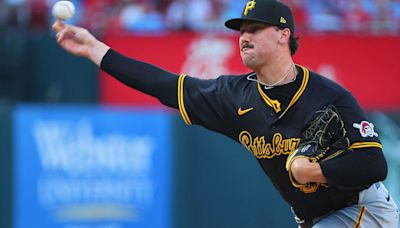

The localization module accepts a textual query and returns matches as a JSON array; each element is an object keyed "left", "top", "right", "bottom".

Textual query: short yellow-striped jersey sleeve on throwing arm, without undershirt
[{"left": 178, "top": 75, "right": 232, "bottom": 135}]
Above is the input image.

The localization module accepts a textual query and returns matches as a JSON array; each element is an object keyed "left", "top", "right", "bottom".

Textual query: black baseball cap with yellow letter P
[{"left": 225, "top": 0, "right": 294, "bottom": 33}]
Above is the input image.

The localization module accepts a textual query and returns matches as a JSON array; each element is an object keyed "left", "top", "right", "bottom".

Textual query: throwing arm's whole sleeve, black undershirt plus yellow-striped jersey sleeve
[{"left": 101, "top": 49, "right": 234, "bottom": 136}]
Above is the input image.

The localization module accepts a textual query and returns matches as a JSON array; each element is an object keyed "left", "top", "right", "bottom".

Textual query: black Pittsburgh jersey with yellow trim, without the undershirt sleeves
[{"left": 178, "top": 66, "right": 382, "bottom": 219}]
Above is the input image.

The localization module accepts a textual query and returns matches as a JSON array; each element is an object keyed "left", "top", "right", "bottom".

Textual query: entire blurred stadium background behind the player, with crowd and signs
[{"left": 0, "top": 0, "right": 400, "bottom": 228}]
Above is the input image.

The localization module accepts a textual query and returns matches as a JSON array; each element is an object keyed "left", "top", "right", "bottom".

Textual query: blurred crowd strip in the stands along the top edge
[{"left": 0, "top": 0, "right": 400, "bottom": 35}]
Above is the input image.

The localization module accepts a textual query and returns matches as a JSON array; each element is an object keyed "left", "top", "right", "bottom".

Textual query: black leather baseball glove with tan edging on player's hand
[{"left": 286, "top": 105, "right": 350, "bottom": 193}]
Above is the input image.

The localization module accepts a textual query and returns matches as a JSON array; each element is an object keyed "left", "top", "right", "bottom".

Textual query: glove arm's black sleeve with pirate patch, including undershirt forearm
[{"left": 320, "top": 91, "right": 387, "bottom": 189}]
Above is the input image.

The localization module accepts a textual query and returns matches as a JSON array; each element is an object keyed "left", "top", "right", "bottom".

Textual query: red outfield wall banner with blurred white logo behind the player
[{"left": 100, "top": 33, "right": 400, "bottom": 110}]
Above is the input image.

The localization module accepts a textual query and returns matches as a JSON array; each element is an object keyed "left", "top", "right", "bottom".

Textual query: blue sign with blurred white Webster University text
[{"left": 14, "top": 106, "right": 171, "bottom": 228}]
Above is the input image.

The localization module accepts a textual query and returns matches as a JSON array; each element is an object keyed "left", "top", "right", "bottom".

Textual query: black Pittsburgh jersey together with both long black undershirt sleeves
[{"left": 101, "top": 49, "right": 387, "bottom": 219}]
